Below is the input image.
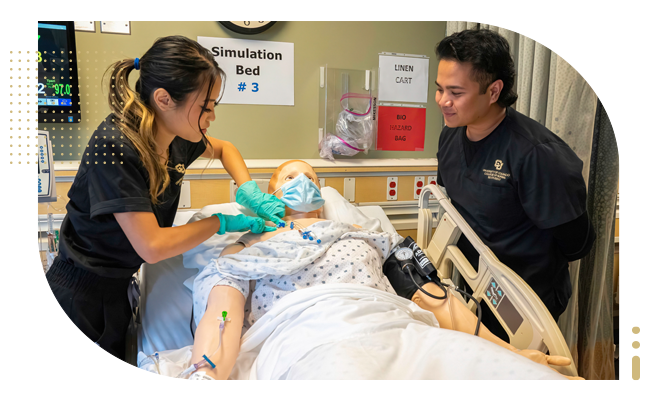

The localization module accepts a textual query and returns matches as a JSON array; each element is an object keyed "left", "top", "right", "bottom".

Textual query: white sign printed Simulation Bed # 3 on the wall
[{"left": 197, "top": 36, "right": 294, "bottom": 106}]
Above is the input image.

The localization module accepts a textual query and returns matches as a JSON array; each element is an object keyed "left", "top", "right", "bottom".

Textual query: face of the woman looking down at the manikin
[{"left": 156, "top": 78, "right": 221, "bottom": 143}]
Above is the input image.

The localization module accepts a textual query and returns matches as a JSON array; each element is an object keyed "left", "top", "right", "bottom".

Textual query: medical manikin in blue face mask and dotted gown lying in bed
[{"left": 187, "top": 160, "right": 570, "bottom": 380}]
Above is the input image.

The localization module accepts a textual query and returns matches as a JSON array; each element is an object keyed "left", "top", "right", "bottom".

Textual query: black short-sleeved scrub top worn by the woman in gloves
[{"left": 59, "top": 114, "right": 206, "bottom": 278}]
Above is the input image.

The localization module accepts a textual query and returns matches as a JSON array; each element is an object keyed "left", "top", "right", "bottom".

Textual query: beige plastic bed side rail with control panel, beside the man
[{"left": 417, "top": 185, "right": 578, "bottom": 376}]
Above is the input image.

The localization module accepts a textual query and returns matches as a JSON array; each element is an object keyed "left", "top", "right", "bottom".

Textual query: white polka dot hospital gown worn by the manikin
[{"left": 193, "top": 221, "right": 403, "bottom": 331}]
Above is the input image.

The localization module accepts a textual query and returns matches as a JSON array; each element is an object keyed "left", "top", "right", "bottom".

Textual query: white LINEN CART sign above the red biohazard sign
[{"left": 379, "top": 55, "right": 429, "bottom": 103}]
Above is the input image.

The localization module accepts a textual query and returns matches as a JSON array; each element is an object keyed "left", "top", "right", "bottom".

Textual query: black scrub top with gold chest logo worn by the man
[{"left": 438, "top": 107, "right": 587, "bottom": 310}]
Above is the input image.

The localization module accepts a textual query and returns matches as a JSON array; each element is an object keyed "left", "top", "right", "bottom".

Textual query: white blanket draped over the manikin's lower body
[{"left": 139, "top": 284, "right": 564, "bottom": 379}]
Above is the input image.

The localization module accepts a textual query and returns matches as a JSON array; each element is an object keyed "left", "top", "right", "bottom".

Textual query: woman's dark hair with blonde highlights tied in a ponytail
[{"left": 107, "top": 36, "right": 226, "bottom": 204}]
